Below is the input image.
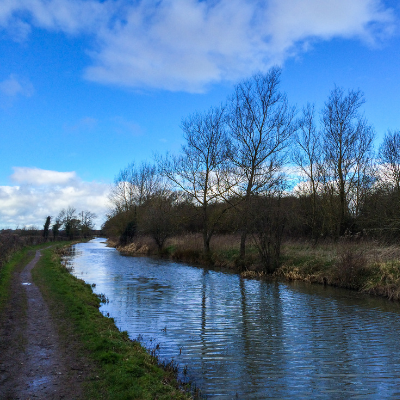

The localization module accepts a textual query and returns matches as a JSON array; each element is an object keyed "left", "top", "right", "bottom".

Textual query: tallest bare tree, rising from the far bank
[{"left": 229, "top": 67, "right": 295, "bottom": 259}]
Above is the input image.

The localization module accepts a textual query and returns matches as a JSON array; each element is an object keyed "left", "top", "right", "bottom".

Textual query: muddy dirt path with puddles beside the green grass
[{"left": 0, "top": 251, "right": 85, "bottom": 400}]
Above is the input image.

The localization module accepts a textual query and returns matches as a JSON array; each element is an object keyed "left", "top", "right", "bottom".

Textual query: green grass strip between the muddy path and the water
[{"left": 33, "top": 247, "right": 189, "bottom": 400}]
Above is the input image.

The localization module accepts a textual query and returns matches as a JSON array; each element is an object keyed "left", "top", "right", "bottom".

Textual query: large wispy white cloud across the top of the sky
[{"left": 0, "top": 0, "right": 394, "bottom": 92}]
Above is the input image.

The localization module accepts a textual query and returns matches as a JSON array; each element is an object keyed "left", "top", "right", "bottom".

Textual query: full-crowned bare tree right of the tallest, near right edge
[{"left": 322, "top": 87, "right": 374, "bottom": 236}]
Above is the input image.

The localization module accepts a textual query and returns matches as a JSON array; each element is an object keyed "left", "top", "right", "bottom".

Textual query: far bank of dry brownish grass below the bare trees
[{"left": 109, "top": 235, "right": 400, "bottom": 300}]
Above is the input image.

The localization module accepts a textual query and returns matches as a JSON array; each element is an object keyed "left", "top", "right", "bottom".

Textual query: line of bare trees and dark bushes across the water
[{"left": 103, "top": 67, "right": 400, "bottom": 272}]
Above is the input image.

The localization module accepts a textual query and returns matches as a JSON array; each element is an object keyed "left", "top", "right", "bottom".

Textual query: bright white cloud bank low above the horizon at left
[{"left": 0, "top": 168, "right": 110, "bottom": 228}]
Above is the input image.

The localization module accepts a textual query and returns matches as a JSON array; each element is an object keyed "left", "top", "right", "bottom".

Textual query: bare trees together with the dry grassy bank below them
[{"left": 103, "top": 68, "right": 400, "bottom": 299}]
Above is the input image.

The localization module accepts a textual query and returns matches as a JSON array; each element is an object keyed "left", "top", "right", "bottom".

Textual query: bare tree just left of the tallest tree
[{"left": 159, "top": 107, "right": 230, "bottom": 254}]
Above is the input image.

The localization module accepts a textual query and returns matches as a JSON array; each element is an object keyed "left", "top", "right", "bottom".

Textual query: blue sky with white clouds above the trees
[{"left": 0, "top": 0, "right": 400, "bottom": 229}]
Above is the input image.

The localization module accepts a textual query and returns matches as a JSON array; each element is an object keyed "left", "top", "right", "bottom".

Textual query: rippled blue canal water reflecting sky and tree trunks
[{"left": 69, "top": 239, "right": 400, "bottom": 400}]
